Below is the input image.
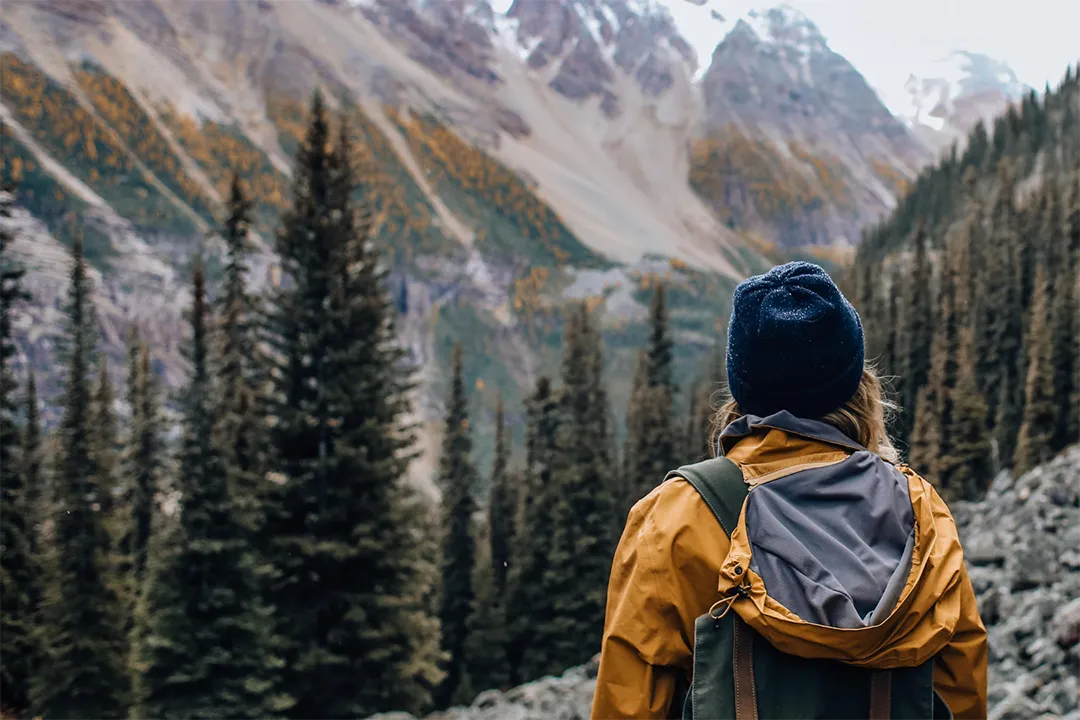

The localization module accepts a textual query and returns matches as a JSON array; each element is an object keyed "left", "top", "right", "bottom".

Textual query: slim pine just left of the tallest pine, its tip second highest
[{"left": 215, "top": 174, "right": 266, "bottom": 527}]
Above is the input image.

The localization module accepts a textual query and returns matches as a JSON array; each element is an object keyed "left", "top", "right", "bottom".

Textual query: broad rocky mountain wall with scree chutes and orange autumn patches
[{"left": 0, "top": 0, "right": 919, "bottom": 473}]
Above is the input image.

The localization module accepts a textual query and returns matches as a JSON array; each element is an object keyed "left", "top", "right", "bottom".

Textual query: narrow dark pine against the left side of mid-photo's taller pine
[{"left": 507, "top": 377, "right": 559, "bottom": 683}]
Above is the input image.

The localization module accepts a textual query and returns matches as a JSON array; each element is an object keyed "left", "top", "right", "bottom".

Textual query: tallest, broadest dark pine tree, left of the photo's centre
[{"left": 260, "top": 94, "right": 441, "bottom": 720}]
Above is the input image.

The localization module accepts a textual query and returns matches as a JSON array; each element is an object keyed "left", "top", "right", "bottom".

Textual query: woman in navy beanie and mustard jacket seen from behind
[{"left": 593, "top": 262, "right": 987, "bottom": 720}]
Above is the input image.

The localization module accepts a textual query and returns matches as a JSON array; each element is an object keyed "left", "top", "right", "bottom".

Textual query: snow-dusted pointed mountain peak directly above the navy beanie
[{"left": 691, "top": 6, "right": 929, "bottom": 246}]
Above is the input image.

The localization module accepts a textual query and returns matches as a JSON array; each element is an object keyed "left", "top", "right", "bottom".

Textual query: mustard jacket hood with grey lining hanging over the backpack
[{"left": 714, "top": 411, "right": 963, "bottom": 668}]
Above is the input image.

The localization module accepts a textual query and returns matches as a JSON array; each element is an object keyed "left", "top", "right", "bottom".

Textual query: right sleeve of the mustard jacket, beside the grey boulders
[{"left": 934, "top": 568, "right": 988, "bottom": 720}]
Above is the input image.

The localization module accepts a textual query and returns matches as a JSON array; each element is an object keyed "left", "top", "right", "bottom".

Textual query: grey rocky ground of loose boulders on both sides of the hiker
[{"left": 369, "top": 448, "right": 1080, "bottom": 720}]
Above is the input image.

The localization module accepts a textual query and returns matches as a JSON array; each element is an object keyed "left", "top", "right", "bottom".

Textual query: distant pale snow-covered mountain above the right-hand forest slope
[{"left": 894, "top": 51, "right": 1031, "bottom": 158}]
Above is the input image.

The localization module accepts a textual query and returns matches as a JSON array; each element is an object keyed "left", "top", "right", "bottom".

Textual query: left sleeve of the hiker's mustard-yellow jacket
[{"left": 592, "top": 507, "right": 692, "bottom": 720}]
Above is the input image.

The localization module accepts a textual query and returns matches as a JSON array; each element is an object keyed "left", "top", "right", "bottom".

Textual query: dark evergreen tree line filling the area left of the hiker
[{"left": 0, "top": 94, "right": 720, "bottom": 720}]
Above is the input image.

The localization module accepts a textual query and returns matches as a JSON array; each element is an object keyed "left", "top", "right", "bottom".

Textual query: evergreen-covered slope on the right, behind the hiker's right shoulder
[{"left": 851, "top": 62, "right": 1080, "bottom": 499}]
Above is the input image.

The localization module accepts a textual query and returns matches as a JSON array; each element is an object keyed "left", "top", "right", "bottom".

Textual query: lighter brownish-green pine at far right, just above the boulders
[{"left": 1013, "top": 264, "right": 1057, "bottom": 475}]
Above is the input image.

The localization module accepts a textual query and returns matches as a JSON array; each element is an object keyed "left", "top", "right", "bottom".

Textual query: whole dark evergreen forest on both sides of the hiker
[{"left": 6, "top": 60, "right": 1080, "bottom": 720}]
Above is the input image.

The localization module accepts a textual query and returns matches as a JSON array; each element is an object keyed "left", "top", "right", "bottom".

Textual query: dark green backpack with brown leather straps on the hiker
[{"left": 667, "top": 458, "right": 953, "bottom": 720}]
